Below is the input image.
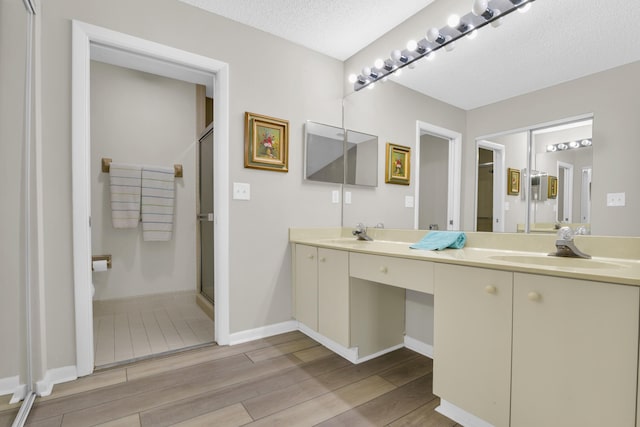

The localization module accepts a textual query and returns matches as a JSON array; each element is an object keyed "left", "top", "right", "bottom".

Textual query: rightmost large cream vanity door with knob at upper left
[{"left": 511, "top": 273, "right": 640, "bottom": 427}]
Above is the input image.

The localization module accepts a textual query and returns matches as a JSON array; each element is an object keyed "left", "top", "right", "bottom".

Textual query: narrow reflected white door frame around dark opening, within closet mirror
[{"left": 473, "top": 139, "right": 507, "bottom": 233}]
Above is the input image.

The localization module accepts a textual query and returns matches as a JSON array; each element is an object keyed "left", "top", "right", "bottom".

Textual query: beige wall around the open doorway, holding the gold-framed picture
[{"left": 41, "top": 0, "right": 343, "bottom": 368}]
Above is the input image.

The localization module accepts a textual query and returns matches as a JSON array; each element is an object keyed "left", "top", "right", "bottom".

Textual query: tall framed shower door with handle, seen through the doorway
[{"left": 198, "top": 125, "right": 214, "bottom": 302}]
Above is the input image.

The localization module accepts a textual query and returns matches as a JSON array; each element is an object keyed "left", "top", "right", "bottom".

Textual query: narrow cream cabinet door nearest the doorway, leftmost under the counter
[{"left": 294, "top": 244, "right": 318, "bottom": 332}]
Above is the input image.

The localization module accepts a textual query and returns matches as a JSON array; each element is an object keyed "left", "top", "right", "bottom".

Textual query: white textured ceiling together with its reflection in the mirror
[{"left": 180, "top": 0, "right": 640, "bottom": 110}]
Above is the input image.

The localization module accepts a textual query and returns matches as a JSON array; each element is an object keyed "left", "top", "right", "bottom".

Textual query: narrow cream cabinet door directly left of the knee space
[{"left": 318, "top": 248, "right": 350, "bottom": 348}]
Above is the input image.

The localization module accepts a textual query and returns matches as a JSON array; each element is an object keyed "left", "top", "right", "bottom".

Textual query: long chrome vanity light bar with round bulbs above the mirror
[{"left": 349, "top": 0, "right": 535, "bottom": 91}]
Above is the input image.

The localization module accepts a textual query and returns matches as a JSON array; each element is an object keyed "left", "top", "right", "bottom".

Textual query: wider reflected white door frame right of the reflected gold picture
[{"left": 413, "top": 120, "right": 462, "bottom": 230}]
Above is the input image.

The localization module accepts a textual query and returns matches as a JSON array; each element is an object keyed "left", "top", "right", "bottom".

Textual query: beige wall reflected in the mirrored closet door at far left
[{"left": 0, "top": 0, "right": 27, "bottom": 384}]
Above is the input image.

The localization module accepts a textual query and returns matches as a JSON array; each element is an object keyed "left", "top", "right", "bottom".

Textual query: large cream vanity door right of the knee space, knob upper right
[{"left": 433, "top": 264, "right": 512, "bottom": 427}]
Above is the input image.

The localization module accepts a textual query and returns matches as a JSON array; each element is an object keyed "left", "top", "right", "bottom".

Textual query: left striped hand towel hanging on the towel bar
[{"left": 109, "top": 162, "right": 142, "bottom": 228}]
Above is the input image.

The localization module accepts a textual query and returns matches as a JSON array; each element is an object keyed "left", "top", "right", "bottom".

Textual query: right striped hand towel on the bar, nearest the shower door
[{"left": 141, "top": 166, "right": 175, "bottom": 241}]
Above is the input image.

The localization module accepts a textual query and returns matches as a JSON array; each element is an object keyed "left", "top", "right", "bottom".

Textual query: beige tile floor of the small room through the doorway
[{"left": 93, "top": 292, "right": 213, "bottom": 367}]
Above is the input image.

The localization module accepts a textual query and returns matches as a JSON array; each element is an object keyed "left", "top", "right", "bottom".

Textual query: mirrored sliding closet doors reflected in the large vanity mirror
[{"left": 475, "top": 118, "right": 593, "bottom": 233}]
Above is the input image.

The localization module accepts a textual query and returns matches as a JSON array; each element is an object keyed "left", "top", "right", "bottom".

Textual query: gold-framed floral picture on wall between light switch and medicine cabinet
[{"left": 244, "top": 112, "right": 289, "bottom": 172}]
